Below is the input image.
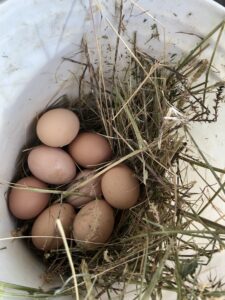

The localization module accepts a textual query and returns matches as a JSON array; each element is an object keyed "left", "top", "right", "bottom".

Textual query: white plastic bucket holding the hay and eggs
[{"left": 0, "top": 0, "right": 225, "bottom": 299}]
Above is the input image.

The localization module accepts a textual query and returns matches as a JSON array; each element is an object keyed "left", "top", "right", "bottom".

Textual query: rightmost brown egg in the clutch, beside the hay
[{"left": 101, "top": 164, "right": 140, "bottom": 209}]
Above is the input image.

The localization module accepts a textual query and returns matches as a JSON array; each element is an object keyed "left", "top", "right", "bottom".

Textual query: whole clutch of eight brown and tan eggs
[{"left": 8, "top": 108, "right": 140, "bottom": 251}]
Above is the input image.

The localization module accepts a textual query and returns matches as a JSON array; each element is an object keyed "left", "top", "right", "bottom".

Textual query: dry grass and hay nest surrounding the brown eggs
[{"left": 5, "top": 9, "right": 224, "bottom": 299}]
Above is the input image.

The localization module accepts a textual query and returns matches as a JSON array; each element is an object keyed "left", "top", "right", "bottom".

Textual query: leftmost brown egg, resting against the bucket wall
[{"left": 8, "top": 176, "right": 50, "bottom": 220}]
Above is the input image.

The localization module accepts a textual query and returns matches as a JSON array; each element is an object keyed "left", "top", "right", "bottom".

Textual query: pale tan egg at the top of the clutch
[{"left": 36, "top": 108, "right": 80, "bottom": 147}]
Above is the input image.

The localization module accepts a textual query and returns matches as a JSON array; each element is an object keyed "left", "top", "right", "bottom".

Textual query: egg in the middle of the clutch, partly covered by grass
[{"left": 67, "top": 170, "right": 102, "bottom": 207}]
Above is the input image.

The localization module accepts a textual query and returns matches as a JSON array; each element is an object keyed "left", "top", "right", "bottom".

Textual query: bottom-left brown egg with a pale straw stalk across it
[{"left": 31, "top": 203, "right": 75, "bottom": 251}]
